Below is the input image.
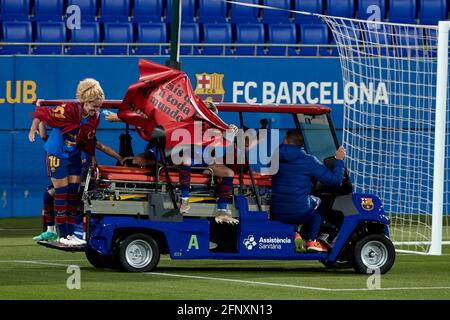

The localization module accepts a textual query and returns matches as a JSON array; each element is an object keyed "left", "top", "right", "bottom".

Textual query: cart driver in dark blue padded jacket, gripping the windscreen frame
[{"left": 271, "top": 130, "right": 345, "bottom": 252}]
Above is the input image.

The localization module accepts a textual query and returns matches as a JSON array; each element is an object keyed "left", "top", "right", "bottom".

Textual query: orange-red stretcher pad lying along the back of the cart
[{"left": 98, "top": 166, "right": 272, "bottom": 187}]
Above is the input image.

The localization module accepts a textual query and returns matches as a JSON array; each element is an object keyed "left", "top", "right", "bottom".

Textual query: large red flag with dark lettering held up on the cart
[{"left": 118, "top": 59, "right": 228, "bottom": 148}]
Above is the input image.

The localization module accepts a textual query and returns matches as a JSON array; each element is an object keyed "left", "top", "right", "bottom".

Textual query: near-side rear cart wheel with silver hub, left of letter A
[{"left": 119, "top": 233, "right": 160, "bottom": 272}]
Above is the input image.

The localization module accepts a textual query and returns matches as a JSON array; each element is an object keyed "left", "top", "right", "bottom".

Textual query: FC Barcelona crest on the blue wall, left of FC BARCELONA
[{"left": 195, "top": 73, "right": 225, "bottom": 102}]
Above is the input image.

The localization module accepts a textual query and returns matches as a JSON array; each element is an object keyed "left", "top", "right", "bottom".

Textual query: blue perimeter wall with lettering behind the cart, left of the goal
[{"left": 0, "top": 56, "right": 343, "bottom": 218}]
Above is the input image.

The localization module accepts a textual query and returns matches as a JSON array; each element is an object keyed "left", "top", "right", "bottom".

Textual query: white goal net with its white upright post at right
[{"left": 320, "top": 16, "right": 450, "bottom": 254}]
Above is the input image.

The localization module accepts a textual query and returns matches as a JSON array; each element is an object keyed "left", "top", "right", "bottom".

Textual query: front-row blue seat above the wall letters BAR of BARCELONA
[{"left": 267, "top": 23, "right": 297, "bottom": 56}]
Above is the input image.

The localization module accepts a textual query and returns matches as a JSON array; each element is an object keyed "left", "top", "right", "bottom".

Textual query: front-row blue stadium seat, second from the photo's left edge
[{"left": 34, "top": 22, "right": 67, "bottom": 54}]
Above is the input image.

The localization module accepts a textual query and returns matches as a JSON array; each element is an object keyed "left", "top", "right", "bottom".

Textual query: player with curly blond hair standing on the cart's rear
[{"left": 28, "top": 79, "right": 105, "bottom": 246}]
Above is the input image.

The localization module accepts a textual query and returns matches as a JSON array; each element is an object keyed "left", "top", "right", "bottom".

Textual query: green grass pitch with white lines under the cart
[{"left": 0, "top": 217, "right": 450, "bottom": 300}]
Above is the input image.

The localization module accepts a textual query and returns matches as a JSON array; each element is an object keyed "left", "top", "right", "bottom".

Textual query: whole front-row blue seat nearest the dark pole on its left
[{"left": 136, "top": 22, "right": 167, "bottom": 55}]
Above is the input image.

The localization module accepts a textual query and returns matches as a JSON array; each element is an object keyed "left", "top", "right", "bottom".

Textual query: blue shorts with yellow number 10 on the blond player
[{"left": 45, "top": 152, "right": 81, "bottom": 179}]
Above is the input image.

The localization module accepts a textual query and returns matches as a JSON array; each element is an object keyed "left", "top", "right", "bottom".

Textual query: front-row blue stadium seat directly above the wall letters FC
[{"left": 235, "top": 23, "right": 265, "bottom": 56}]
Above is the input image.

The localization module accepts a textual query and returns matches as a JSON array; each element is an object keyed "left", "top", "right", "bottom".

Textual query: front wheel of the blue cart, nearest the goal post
[{"left": 353, "top": 234, "right": 395, "bottom": 274}]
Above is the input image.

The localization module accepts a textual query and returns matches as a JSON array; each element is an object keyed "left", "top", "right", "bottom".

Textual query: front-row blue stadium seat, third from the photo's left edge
[{"left": 67, "top": 22, "right": 100, "bottom": 55}]
